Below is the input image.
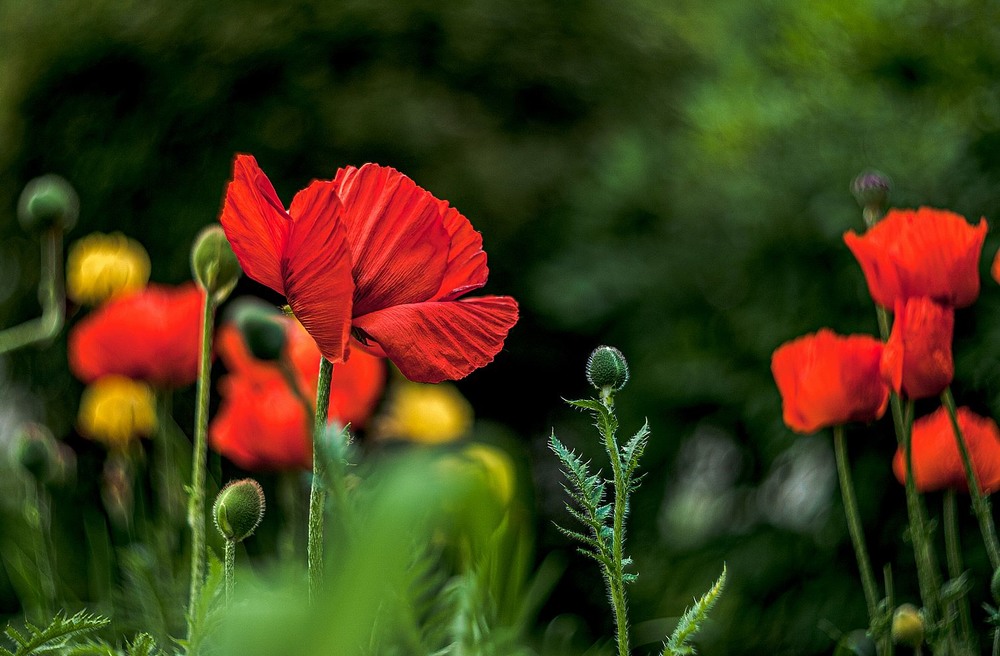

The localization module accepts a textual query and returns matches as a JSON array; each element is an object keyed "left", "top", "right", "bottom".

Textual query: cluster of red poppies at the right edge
[{"left": 771, "top": 208, "right": 1000, "bottom": 492}]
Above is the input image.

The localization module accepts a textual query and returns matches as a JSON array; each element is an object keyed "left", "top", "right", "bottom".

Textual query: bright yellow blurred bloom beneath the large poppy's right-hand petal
[{"left": 375, "top": 381, "right": 473, "bottom": 444}]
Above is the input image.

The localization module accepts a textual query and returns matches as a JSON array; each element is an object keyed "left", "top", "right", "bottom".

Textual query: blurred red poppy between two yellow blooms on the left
[{"left": 69, "top": 283, "right": 205, "bottom": 388}]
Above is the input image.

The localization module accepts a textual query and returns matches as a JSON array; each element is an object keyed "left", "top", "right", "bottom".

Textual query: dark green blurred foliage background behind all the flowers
[{"left": 0, "top": 0, "right": 1000, "bottom": 655}]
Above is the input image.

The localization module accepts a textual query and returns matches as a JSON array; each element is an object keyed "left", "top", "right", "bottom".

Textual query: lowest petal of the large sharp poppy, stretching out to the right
[{"left": 354, "top": 296, "right": 517, "bottom": 383}]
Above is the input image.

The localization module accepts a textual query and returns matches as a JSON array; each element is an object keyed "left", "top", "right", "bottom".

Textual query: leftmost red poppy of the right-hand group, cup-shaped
[{"left": 771, "top": 329, "right": 889, "bottom": 433}]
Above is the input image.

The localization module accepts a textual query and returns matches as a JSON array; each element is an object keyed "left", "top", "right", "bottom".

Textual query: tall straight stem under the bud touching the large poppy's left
[{"left": 188, "top": 294, "right": 215, "bottom": 639}]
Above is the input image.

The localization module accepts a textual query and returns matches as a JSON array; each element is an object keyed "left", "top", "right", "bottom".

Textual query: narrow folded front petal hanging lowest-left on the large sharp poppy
[{"left": 281, "top": 181, "right": 354, "bottom": 362}]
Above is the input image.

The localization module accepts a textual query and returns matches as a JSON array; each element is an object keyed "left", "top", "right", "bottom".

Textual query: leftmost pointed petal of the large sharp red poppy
[{"left": 219, "top": 155, "right": 291, "bottom": 294}]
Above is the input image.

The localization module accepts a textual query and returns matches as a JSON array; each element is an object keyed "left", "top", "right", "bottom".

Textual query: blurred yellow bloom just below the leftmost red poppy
[{"left": 77, "top": 376, "right": 156, "bottom": 450}]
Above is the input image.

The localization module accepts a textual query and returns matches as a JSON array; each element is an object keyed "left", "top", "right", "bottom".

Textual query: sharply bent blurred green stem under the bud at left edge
[{"left": 0, "top": 228, "right": 66, "bottom": 355}]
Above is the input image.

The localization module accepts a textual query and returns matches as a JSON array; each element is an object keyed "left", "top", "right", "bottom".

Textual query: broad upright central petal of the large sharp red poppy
[{"left": 334, "top": 164, "right": 449, "bottom": 315}]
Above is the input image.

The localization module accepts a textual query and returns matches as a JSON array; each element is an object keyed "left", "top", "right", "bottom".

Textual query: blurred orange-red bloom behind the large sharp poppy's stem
[{"left": 209, "top": 318, "right": 385, "bottom": 471}]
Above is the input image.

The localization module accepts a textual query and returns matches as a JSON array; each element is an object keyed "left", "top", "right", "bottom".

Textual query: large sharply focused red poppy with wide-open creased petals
[{"left": 220, "top": 155, "right": 518, "bottom": 382}]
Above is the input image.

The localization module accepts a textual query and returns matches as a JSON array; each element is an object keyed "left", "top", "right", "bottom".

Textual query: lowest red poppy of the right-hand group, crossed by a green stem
[{"left": 892, "top": 408, "right": 1000, "bottom": 494}]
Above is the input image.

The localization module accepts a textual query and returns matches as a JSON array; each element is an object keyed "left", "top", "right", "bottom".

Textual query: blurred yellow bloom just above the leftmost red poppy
[{"left": 66, "top": 232, "right": 149, "bottom": 305}]
